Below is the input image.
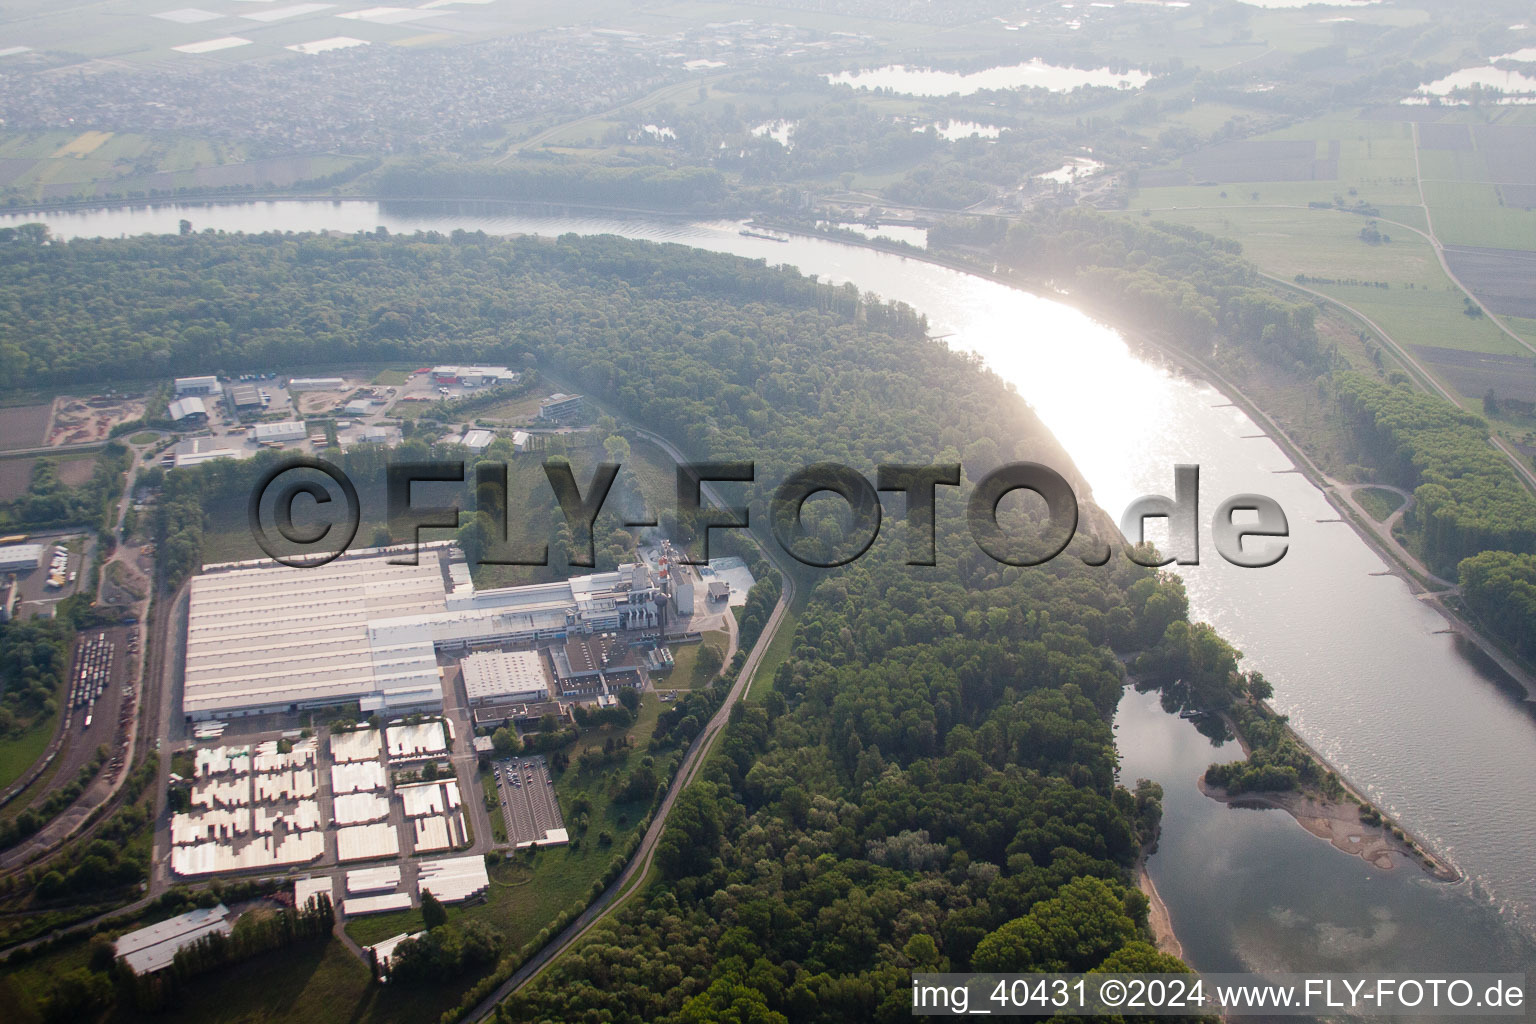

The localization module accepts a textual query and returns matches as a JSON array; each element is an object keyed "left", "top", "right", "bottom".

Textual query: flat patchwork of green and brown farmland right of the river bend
[{"left": 1130, "top": 107, "right": 1536, "bottom": 407}]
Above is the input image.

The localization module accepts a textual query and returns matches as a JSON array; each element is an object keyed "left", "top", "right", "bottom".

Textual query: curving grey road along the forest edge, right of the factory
[{"left": 465, "top": 428, "right": 794, "bottom": 1022}]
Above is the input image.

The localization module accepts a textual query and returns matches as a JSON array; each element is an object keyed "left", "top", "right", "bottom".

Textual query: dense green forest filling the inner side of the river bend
[{"left": 0, "top": 235, "right": 1222, "bottom": 1021}]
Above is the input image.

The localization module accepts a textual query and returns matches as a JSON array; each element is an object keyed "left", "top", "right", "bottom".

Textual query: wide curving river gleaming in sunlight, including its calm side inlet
[{"left": 0, "top": 201, "right": 1536, "bottom": 994}]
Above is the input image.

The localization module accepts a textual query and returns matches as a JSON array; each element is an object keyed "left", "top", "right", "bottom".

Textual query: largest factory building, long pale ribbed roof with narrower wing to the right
[{"left": 181, "top": 542, "right": 665, "bottom": 722}]
